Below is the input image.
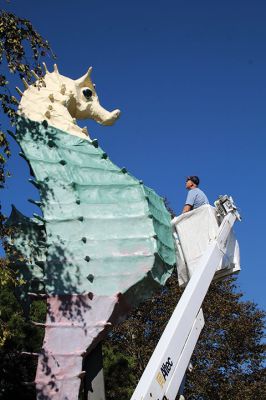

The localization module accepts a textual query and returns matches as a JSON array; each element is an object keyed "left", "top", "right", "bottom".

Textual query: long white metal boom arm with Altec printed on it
[{"left": 131, "top": 196, "right": 240, "bottom": 400}]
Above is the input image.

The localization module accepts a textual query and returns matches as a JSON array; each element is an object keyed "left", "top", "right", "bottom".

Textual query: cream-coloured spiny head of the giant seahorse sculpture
[{"left": 18, "top": 64, "right": 120, "bottom": 140}]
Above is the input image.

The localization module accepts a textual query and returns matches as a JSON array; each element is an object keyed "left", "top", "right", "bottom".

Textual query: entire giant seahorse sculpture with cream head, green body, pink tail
[{"left": 8, "top": 65, "right": 176, "bottom": 400}]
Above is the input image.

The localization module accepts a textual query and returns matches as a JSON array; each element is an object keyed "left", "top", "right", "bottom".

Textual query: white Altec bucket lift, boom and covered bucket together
[{"left": 88, "top": 195, "right": 241, "bottom": 400}]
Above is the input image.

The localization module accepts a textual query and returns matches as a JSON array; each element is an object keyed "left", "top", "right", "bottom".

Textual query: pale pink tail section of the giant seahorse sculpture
[{"left": 35, "top": 294, "right": 118, "bottom": 400}]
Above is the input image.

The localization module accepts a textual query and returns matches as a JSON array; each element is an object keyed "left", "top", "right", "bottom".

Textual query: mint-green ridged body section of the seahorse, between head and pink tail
[{"left": 11, "top": 117, "right": 176, "bottom": 301}]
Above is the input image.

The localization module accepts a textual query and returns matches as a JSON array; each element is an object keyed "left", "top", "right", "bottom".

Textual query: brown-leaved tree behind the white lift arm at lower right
[{"left": 103, "top": 276, "right": 266, "bottom": 400}]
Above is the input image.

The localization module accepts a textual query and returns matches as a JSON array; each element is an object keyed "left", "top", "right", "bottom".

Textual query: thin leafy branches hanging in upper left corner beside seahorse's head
[{"left": 0, "top": 10, "right": 51, "bottom": 185}]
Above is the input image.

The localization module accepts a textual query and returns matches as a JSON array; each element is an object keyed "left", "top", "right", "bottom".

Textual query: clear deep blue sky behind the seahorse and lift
[{"left": 1, "top": 0, "right": 266, "bottom": 308}]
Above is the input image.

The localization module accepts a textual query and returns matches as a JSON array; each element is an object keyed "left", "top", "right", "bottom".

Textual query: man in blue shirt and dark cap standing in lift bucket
[{"left": 183, "top": 176, "right": 209, "bottom": 213}]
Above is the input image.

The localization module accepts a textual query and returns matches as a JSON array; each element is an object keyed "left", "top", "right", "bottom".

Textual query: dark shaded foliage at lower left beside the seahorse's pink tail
[{"left": 0, "top": 286, "right": 46, "bottom": 400}]
